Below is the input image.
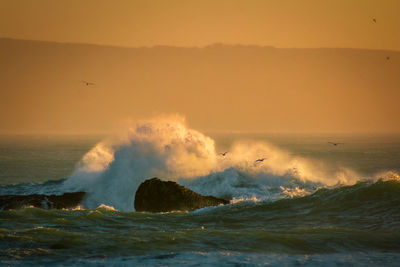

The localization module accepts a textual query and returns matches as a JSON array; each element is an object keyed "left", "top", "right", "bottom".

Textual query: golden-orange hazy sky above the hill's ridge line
[{"left": 0, "top": 0, "right": 400, "bottom": 50}]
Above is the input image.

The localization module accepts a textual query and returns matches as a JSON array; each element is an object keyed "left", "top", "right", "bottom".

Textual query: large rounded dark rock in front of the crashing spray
[{"left": 135, "top": 178, "right": 229, "bottom": 212}]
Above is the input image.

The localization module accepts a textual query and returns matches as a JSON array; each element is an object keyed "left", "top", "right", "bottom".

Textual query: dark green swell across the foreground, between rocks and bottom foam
[{"left": 0, "top": 180, "right": 400, "bottom": 257}]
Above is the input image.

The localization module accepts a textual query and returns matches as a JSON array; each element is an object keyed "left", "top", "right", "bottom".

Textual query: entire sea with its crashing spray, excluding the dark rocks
[{"left": 0, "top": 119, "right": 400, "bottom": 266}]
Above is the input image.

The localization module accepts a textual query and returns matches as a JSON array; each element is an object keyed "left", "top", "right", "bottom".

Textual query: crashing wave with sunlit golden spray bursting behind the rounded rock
[{"left": 54, "top": 116, "right": 397, "bottom": 211}]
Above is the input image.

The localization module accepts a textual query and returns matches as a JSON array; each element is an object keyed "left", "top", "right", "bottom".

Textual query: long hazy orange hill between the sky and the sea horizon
[{"left": 0, "top": 39, "right": 400, "bottom": 133}]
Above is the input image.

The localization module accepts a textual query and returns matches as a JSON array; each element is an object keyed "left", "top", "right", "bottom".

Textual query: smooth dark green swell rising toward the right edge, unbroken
[{"left": 199, "top": 180, "right": 400, "bottom": 231}]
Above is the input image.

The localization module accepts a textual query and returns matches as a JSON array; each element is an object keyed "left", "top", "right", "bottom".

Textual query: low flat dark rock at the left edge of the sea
[{"left": 0, "top": 192, "right": 85, "bottom": 210}]
